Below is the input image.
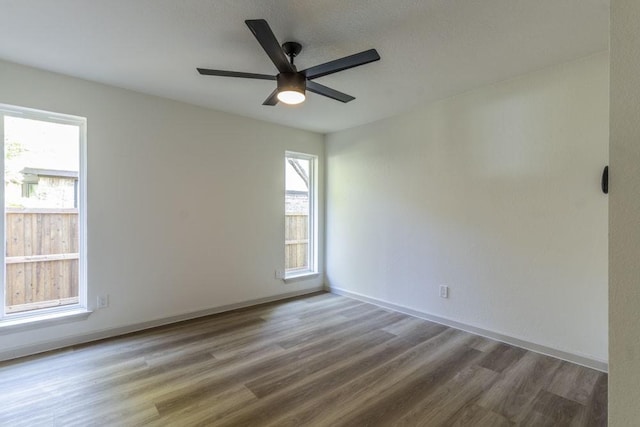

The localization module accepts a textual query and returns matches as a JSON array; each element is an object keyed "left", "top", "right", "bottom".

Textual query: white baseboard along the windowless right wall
[{"left": 325, "top": 286, "right": 609, "bottom": 372}]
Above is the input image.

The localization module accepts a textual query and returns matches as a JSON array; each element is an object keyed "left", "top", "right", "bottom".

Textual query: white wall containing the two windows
[{"left": 0, "top": 62, "right": 324, "bottom": 360}]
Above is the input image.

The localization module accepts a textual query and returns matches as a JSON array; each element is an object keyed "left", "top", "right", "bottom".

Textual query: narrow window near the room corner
[{"left": 285, "top": 152, "right": 317, "bottom": 278}]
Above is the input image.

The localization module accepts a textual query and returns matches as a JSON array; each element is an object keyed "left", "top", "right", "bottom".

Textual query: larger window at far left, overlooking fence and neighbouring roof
[{"left": 0, "top": 105, "right": 86, "bottom": 321}]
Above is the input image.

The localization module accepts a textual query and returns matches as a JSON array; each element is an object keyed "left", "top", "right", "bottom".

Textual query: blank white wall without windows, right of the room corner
[{"left": 326, "top": 53, "right": 608, "bottom": 362}]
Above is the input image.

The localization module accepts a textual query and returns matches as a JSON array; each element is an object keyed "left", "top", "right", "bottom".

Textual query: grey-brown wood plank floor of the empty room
[{"left": 0, "top": 293, "right": 607, "bottom": 427}]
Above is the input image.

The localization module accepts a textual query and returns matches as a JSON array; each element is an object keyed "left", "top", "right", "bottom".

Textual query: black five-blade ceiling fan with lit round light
[{"left": 197, "top": 19, "right": 380, "bottom": 105}]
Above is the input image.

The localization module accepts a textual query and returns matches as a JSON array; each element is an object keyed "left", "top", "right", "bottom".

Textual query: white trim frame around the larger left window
[{"left": 0, "top": 104, "right": 91, "bottom": 333}]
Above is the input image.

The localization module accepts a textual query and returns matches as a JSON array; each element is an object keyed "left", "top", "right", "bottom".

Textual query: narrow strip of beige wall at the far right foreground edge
[{"left": 609, "top": 0, "right": 640, "bottom": 427}]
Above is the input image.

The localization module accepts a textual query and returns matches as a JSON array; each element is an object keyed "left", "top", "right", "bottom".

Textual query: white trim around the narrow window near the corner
[{"left": 283, "top": 151, "right": 319, "bottom": 282}]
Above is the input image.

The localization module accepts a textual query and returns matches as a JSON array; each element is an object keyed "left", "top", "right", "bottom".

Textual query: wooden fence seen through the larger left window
[{"left": 5, "top": 209, "right": 79, "bottom": 313}]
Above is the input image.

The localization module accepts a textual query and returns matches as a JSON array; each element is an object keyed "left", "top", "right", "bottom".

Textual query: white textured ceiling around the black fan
[{"left": 0, "top": 0, "right": 609, "bottom": 132}]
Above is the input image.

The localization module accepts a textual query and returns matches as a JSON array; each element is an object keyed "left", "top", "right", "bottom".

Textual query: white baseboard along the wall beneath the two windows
[{"left": 0, "top": 286, "right": 326, "bottom": 362}]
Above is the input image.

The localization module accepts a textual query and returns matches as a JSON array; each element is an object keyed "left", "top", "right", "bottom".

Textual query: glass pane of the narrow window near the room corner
[{"left": 285, "top": 157, "right": 312, "bottom": 272}]
